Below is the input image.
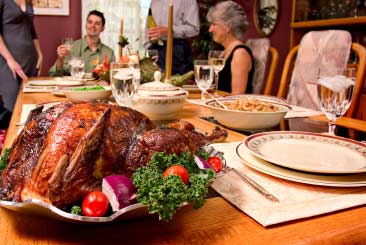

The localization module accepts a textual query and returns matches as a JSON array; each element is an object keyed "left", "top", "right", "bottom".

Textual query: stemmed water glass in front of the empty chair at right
[{"left": 317, "top": 68, "right": 356, "bottom": 135}]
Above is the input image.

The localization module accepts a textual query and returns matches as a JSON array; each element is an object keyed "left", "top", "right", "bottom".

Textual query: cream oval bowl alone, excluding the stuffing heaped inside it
[{"left": 206, "top": 98, "right": 290, "bottom": 130}]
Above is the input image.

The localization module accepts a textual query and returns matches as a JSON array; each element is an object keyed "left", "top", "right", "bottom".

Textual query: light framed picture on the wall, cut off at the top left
[{"left": 33, "top": 0, "right": 70, "bottom": 15}]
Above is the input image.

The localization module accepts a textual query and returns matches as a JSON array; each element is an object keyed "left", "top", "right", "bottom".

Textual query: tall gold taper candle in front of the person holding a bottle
[{"left": 165, "top": 1, "right": 173, "bottom": 82}]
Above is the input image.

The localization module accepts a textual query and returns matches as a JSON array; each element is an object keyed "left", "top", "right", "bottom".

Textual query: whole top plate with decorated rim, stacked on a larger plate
[{"left": 244, "top": 131, "right": 366, "bottom": 174}]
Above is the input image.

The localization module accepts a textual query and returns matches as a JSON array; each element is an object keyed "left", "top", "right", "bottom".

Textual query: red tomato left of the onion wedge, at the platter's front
[{"left": 82, "top": 191, "right": 109, "bottom": 217}]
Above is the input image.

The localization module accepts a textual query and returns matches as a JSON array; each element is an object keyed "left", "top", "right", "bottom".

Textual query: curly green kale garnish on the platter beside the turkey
[{"left": 132, "top": 150, "right": 215, "bottom": 220}]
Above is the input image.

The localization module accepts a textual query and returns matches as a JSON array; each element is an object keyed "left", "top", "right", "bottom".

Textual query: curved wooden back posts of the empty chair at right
[{"left": 277, "top": 43, "right": 366, "bottom": 118}]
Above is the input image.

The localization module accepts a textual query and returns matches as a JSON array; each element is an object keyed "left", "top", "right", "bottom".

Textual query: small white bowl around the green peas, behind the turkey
[{"left": 63, "top": 86, "right": 112, "bottom": 101}]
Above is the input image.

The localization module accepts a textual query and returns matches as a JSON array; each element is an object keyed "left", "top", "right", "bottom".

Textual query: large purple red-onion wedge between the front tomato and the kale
[{"left": 102, "top": 175, "right": 135, "bottom": 211}]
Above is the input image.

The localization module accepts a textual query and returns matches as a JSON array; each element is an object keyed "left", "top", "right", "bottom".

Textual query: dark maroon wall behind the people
[{"left": 35, "top": 0, "right": 291, "bottom": 94}]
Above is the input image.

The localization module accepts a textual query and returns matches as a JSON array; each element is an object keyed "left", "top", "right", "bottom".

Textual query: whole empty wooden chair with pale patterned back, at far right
[{"left": 277, "top": 30, "right": 366, "bottom": 138}]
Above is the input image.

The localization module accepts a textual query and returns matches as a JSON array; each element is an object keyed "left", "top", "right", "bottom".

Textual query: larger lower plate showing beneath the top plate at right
[{"left": 236, "top": 143, "right": 366, "bottom": 187}]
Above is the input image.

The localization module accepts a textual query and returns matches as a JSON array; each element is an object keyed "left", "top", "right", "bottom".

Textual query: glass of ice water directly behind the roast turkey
[{"left": 110, "top": 62, "right": 139, "bottom": 107}]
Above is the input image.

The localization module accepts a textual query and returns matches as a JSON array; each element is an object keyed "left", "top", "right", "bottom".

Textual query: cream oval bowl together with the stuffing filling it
[{"left": 206, "top": 96, "right": 290, "bottom": 131}]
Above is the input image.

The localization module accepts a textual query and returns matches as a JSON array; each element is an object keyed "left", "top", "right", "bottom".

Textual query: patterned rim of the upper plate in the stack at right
[{"left": 243, "top": 131, "right": 366, "bottom": 174}]
